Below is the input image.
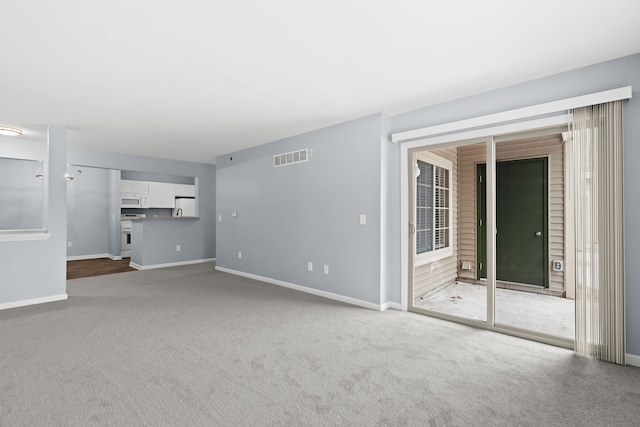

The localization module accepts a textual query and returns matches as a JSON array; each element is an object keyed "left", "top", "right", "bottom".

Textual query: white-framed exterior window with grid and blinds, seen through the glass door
[{"left": 415, "top": 154, "right": 452, "bottom": 262}]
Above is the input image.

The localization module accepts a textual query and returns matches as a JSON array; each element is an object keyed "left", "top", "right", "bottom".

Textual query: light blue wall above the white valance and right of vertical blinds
[{"left": 391, "top": 54, "right": 640, "bottom": 355}]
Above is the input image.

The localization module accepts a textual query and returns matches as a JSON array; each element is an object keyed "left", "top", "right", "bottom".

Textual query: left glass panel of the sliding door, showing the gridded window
[{"left": 410, "top": 142, "right": 487, "bottom": 322}]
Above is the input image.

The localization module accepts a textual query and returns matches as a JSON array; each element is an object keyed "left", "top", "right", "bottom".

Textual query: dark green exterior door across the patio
[{"left": 477, "top": 158, "right": 549, "bottom": 287}]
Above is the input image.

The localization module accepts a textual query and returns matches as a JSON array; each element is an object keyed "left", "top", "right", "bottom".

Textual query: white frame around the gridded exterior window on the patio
[{"left": 413, "top": 152, "right": 454, "bottom": 266}]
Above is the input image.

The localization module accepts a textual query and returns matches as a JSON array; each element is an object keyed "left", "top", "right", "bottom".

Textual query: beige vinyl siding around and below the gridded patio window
[{"left": 413, "top": 148, "right": 458, "bottom": 303}]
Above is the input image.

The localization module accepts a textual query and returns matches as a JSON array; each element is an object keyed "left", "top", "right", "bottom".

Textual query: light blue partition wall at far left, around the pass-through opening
[{"left": 0, "top": 125, "right": 67, "bottom": 304}]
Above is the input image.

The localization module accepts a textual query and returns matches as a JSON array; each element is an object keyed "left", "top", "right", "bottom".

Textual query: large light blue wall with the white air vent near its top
[{"left": 216, "top": 115, "right": 382, "bottom": 304}]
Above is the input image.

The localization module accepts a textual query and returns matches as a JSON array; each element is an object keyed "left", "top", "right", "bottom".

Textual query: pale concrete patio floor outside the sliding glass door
[{"left": 416, "top": 282, "right": 575, "bottom": 339}]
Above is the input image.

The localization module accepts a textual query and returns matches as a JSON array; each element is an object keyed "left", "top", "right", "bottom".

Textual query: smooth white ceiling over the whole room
[{"left": 0, "top": 0, "right": 640, "bottom": 163}]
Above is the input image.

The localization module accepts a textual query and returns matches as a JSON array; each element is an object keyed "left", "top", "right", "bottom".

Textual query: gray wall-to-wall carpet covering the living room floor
[{"left": 0, "top": 264, "right": 640, "bottom": 426}]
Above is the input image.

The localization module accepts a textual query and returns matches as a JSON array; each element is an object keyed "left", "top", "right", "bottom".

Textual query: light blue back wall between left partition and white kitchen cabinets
[{"left": 67, "top": 166, "right": 110, "bottom": 257}]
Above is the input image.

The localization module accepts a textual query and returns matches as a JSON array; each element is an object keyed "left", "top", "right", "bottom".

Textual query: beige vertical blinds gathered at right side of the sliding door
[{"left": 571, "top": 101, "right": 625, "bottom": 364}]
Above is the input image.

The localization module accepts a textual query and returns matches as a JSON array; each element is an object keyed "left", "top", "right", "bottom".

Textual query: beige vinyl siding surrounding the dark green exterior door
[{"left": 458, "top": 135, "right": 565, "bottom": 292}]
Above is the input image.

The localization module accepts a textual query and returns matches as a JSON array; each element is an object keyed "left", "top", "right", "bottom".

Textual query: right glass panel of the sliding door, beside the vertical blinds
[{"left": 490, "top": 134, "right": 575, "bottom": 340}]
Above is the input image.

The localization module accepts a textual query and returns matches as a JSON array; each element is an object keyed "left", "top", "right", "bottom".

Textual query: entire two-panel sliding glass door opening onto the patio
[{"left": 409, "top": 127, "right": 575, "bottom": 346}]
